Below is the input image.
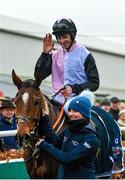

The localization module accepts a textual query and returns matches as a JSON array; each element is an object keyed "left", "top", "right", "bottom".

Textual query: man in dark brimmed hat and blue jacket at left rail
[{"left": 0, "top": 99, "right": 18, "bottom": 150}]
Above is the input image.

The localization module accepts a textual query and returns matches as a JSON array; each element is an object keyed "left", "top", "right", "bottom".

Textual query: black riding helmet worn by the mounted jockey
[{"left": 52, "top": 18, "right": 77, "bottom": 41}]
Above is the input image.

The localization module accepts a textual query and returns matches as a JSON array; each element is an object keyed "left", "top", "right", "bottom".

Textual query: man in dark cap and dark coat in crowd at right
[{"left": 109, "top": 97, "right": 120, "bottom": 121}]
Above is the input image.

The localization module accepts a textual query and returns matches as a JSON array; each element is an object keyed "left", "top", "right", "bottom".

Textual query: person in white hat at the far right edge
[{"left": 118, "top": 109, "right": 125, "bottom": 141}]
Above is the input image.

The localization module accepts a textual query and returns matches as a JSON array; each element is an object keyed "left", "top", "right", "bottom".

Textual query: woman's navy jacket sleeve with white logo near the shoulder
[{"left": 39, "top": 135, "right": 99, "bottom": 165}]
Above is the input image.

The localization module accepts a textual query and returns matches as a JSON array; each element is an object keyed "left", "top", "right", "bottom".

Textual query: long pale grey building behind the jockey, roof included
[{"left": 0, "top": 16, "right": 125, "bottom": 99}]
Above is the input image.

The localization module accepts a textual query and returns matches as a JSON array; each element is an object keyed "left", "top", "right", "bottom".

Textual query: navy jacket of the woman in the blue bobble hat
[{"left": 39, "top": 116, "right": 99, "bottom": 179}]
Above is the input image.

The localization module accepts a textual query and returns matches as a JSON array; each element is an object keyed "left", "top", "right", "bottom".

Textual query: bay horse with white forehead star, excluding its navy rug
[{"left": 12, "top": 70, "right": 64, "bottom": 179}]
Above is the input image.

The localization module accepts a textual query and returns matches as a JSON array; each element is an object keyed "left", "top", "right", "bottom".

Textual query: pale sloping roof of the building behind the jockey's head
[{"left": 0, "top": 15, "right": 125, "bottom": 56}]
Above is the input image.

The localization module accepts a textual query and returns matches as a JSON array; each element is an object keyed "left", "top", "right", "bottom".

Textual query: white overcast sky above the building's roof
[{"left": 0, "top": 0, "right": 125, "bottom": 44}]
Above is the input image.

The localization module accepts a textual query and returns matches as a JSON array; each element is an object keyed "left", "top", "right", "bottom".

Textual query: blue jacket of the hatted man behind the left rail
[{"left": 0, "top": 115, "right": 17, "bottom": 149}]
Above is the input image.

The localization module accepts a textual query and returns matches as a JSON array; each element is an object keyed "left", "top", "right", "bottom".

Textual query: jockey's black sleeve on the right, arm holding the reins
[{"left": 72, "top": 54, "right": 100, "bottom": 94}]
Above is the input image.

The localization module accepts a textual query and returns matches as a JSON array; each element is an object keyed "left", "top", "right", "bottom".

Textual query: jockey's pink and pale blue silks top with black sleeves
[{"left": 34, "top": 42, "right": 99, "bottom": 101}]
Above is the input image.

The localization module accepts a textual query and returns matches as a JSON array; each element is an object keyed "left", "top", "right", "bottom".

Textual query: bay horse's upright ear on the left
[{"left": 12, "top": 69, "right": 23, "bottom": 89}]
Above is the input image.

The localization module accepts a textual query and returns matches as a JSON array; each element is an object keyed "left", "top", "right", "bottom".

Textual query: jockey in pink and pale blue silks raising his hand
[{"left": 34, "top": 18, "right": 100, "bottom": 104}]
